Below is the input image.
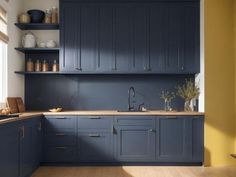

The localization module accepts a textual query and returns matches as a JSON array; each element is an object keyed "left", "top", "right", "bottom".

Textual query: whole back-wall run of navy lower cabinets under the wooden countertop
[{"left": 42, "top": 116, "right": 204, "bottom": 163}]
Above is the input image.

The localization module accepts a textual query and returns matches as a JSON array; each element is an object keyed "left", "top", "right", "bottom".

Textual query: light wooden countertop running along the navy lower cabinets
[{"left": 0, "top": 110, "right": 204, "bottom": 125}]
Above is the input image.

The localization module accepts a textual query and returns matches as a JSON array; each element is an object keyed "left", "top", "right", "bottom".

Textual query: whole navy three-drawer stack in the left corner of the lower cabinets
[{"left": 43, "top": 116, "right": 77, "bottom": 163}]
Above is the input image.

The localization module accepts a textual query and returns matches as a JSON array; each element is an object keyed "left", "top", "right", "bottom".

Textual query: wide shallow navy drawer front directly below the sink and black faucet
[{"left": 115, "top": 116, "right": 155, "bottom": 126}]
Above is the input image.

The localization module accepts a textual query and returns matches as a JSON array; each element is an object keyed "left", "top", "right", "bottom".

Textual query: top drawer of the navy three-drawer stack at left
[{"left": 45, "top": 116, "right": 76, "bottom": 132}]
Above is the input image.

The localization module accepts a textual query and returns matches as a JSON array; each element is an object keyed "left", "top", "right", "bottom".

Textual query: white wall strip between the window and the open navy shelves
[{"left": 0, "top": 0, "right": 24, "bottom": 107}]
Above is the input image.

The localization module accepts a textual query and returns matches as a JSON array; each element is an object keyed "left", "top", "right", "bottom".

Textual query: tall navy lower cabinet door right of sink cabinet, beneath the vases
[{"left": 156, "top": 117, "right": 191, "bottom": 162}]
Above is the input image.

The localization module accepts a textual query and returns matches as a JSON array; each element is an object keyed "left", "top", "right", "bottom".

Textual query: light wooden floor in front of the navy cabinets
[{"left": 32, "top": 166, "right": 236, "bottom": 177}]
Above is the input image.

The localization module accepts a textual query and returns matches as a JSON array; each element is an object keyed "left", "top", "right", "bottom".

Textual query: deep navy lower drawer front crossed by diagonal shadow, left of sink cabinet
[{"left": 78, "top": 131, "right": 113, "bottom": 162}]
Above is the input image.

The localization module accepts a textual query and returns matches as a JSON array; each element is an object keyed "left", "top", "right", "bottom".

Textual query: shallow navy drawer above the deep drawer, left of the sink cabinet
[{"left": 78, "top": 116, "right": 113, "bottom": 130}]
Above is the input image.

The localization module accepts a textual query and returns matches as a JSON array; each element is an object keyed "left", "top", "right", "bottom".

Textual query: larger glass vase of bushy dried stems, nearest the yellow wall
[{"left": 176, "top": 79, "right": 200, "bottom": 111}]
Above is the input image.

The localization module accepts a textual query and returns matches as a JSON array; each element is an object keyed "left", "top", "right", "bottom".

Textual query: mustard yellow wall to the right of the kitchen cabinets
[{"left": 204, "top": 0, "right": 236, "bottom": 166}]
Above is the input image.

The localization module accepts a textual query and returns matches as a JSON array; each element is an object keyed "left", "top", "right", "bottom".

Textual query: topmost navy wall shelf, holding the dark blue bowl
[{"left": 15, "top": 23, "right": 59, "bottom": 30}]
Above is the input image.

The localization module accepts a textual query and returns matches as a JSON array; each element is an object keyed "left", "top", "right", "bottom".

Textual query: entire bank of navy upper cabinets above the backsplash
[{"left": 60, "top": 0, "right": 200, "bottom": 74}]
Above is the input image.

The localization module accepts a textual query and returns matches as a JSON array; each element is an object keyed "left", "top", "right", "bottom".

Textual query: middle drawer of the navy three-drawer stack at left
[{"left": 44, "top": 131, "right": 76, "bottom": 147}]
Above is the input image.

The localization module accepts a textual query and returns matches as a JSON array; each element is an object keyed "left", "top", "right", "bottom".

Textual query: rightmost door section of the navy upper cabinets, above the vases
[{"left": 166, "top": 2, "right": 200, "bottom": 73}]
